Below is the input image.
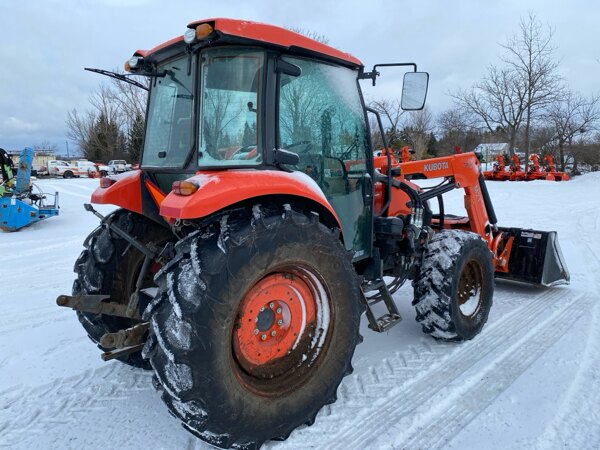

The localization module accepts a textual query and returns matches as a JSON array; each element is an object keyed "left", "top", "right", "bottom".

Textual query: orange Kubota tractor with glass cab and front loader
[{"left": 57, "top": 19, "right": 569, "bottom": 448}]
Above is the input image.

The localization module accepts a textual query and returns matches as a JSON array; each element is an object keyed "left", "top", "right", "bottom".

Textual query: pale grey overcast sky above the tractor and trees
[{"left": 0, "top": 0, "right": 600, "bottom": 153}]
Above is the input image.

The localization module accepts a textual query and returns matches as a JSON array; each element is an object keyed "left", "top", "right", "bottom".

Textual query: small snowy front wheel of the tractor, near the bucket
[{"left": 413, "top": 230, "right": 494, "bottom": 341}]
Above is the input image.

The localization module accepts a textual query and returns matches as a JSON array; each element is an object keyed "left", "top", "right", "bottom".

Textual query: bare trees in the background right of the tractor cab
[{"left": 371, "top": 13, "right": 600, "bottom": 172}]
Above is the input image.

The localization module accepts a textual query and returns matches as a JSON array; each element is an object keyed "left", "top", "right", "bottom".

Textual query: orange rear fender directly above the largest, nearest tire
[{"left": 160, "top": 170, "right": 341, "bottom": 229}]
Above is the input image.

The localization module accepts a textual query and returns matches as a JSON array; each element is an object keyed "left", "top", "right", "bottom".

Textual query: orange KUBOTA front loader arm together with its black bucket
[{"left": 375, "top": 153, "right": 569, "bottom": 286}]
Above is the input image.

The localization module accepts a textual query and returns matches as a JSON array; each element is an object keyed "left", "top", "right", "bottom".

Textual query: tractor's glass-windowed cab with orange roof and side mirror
[{"left": 103, "top": 19, "right": 428, "bottom": 258}]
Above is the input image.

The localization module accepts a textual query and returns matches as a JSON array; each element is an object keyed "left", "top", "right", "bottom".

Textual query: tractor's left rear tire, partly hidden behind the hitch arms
[{"left": 73, "top": 209, "right": 175, "bottom": 369}]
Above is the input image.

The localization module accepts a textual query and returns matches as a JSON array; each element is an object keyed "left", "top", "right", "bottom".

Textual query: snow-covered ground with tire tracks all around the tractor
[{"left": 0, "top": 173, "right": 600, "bottom": 450}]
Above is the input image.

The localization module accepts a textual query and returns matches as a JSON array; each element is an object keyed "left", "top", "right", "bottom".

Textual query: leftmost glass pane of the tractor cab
[{"left": 142, "top": 56, "right": 194, "bottom": 168}]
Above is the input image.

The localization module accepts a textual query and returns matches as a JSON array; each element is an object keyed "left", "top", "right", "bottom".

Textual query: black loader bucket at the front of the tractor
[{"left": 496, "top": 228, "right": 570, "bottom": 286}]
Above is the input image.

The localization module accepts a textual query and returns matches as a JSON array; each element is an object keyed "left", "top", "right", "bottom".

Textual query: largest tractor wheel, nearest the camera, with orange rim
[{"left": 144, "top": 208, "right": 361, "bottom": 448}]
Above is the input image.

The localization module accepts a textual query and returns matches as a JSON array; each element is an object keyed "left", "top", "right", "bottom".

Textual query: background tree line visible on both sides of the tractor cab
[{"left": 66, "top": 12, "right": 600, "bottom": 171}]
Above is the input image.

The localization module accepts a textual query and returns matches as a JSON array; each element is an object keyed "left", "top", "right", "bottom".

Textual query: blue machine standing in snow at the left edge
[{"left": 0, "top": 147, "right": 59, "bottom": 231}]
